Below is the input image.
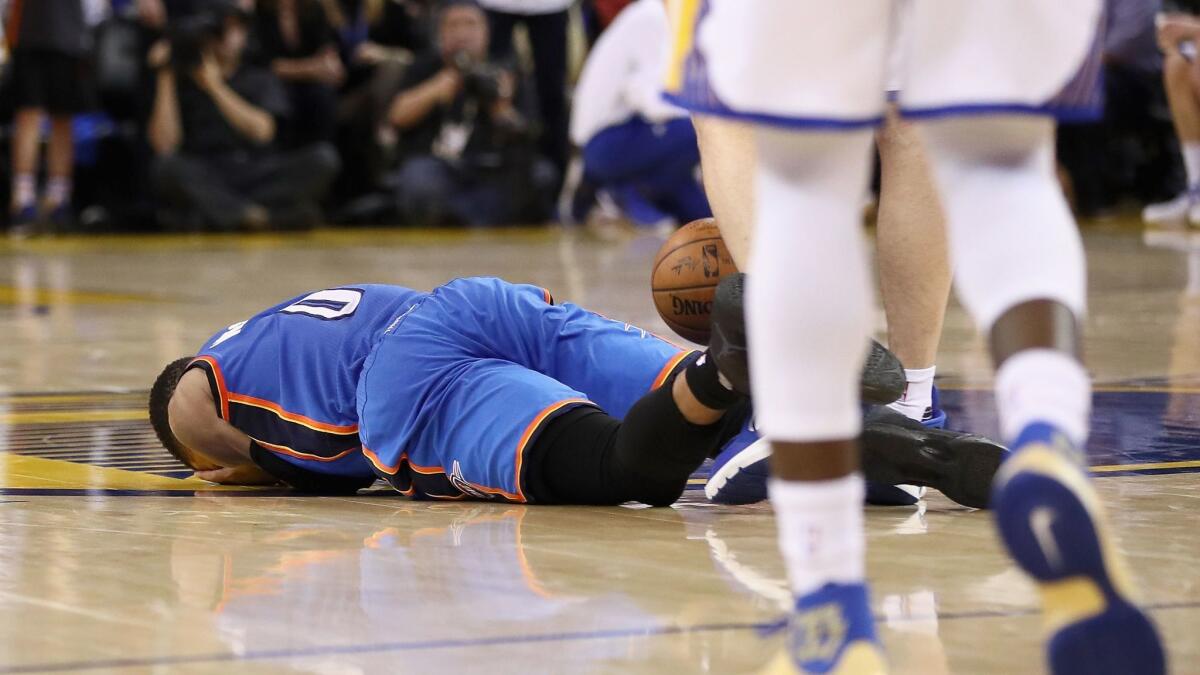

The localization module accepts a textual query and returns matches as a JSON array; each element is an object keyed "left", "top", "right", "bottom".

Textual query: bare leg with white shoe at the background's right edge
[{"left": 1142, "top": 47, "right": 1200, "bottom": 225}]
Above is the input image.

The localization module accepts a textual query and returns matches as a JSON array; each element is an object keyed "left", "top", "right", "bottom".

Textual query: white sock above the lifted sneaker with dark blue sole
[{"left": 996, "top": 348, "right": 1092, "bottom": 448}]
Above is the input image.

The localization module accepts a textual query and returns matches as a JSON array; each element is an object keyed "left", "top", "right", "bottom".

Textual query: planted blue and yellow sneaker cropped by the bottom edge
[{"left": 762, "top": 584, "right": 887, "bottom": 675}]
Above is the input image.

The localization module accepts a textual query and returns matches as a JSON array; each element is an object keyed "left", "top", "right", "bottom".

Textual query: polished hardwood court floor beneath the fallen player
[{"left": 0, "top": 228, "right": 1200, "bottom": 674}]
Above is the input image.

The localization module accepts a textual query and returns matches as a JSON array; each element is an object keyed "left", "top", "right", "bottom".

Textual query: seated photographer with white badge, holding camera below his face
[{"left": 389, "top": 0, "right": 557, "bottom": 226}]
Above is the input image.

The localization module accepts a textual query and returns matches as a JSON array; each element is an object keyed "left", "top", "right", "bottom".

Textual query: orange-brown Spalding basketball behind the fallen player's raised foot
[{"left": 650, "top": 217, "right": 738, "bottom": 345}]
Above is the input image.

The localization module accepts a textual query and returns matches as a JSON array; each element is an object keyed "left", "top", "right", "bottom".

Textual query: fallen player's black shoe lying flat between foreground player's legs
[{"left": 863, "top": 412, "right": 1009, "bottom": 508}]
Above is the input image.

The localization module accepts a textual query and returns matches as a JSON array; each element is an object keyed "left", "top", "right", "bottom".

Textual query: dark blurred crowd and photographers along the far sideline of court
[{"left": 0, "top": 0, "right": 1200, "bottom": 234}]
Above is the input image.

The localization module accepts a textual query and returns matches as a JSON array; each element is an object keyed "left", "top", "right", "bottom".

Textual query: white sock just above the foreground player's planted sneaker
[{"left": 768, "top": 473, "right": 866, "bottom": 596}]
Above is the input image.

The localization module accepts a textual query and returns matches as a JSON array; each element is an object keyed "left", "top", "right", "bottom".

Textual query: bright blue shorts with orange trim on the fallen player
[{"left": 358, "top": 279, "right": 691, "bottom": 502}]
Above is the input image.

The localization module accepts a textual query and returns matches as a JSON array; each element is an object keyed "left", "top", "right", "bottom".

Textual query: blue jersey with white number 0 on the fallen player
[{"left": 192, "top": 283, "right": 426, "bottom": 476}]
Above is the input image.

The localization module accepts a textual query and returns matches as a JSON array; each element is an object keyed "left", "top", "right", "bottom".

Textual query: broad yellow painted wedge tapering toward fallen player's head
[{"left": 0, "top": 453, "right": 246, "bottom": 490}]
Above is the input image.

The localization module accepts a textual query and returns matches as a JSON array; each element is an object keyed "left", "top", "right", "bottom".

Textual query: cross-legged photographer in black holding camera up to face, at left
[{"left": 149, "top": 0, "right": 338, "bottom": 231}]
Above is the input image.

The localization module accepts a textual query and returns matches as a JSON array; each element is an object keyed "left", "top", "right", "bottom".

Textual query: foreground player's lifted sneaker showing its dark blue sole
[{"left": 992, "top": 423, "right": 1166, "bottom": 675}]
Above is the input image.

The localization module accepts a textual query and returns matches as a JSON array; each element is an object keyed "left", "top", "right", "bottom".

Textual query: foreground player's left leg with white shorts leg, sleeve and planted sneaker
[{"left": 667, "top": 0, "right": 888, "bottom": 673}]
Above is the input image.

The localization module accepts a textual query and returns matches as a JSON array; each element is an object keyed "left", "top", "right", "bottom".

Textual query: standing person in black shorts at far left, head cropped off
[{"left": 5, "top": 0, "right": 92, "bottom": 235}]
